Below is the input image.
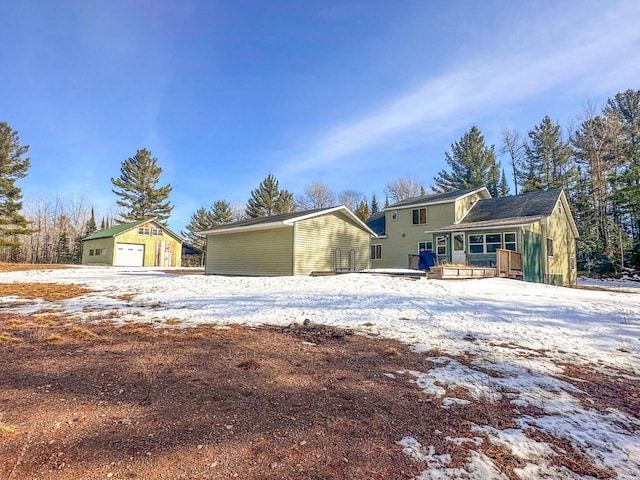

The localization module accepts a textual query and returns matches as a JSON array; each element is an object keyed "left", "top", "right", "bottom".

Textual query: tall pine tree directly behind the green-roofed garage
[{"left": 111, "top": 149, "right": 173, "bottom": 225}]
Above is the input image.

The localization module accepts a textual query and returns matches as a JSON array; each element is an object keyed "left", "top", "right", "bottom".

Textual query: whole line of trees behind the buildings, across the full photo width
[{"left": 0, "top": 90, "right": 640, "bottom": 271}]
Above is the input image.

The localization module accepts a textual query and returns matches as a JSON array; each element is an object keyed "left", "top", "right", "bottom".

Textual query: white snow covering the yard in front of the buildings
[{"left": 0, "top": 267, "right": 640, "bottom": 480}]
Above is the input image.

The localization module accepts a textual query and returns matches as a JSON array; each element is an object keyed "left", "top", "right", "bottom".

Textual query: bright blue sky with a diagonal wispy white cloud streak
[{"left": 0, "top": 0, "right": 640, "bottom": 231}]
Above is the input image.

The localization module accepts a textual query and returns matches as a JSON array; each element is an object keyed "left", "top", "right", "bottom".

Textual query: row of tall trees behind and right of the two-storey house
[{"left": 433, "top": 90, "right": 640, "bottom": 271}]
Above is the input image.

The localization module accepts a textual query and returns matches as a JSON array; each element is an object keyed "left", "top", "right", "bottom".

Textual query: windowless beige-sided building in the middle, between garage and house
[{"left": 201, "top": 206, "right": 375, "bottom": 276}]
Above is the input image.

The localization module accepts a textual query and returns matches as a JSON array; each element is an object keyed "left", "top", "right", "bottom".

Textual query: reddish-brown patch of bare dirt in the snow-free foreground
[{"left": 0, "top": 311, "right": 632, "bottom": 480}]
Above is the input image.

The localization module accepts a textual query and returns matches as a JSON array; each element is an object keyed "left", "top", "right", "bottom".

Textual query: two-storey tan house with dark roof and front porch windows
[{"left": 367, "top": 187, "right": 578, "bottom": 285}]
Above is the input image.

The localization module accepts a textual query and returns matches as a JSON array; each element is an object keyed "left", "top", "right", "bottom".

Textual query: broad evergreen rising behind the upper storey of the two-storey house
[{"left": 434, "top": 125, "right": 500, "bottom": 197}]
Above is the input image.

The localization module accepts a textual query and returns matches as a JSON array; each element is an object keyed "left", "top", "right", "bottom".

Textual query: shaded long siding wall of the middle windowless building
[{"left": 205, "top": 226, "right": 293, "bottom": 275}]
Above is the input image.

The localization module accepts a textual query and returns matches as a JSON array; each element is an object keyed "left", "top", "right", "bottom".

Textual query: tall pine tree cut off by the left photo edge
[{"left": 0, "top": 122, "right": 33, "bottom": 247}]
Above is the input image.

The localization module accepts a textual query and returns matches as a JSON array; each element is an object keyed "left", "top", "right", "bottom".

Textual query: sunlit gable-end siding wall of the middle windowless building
[{"left": 294, "top": 212, "right": 370, "bottom": 275}]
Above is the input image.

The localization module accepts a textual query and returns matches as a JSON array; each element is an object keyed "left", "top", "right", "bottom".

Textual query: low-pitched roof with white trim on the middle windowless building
[{"left": 197, "top": 205, "right": 375, "bottom": 235}]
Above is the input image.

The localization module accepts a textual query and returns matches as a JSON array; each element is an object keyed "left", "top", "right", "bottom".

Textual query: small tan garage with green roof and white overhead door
[{"left": 82, "top": 219, "right": 182, "bottom": 267}]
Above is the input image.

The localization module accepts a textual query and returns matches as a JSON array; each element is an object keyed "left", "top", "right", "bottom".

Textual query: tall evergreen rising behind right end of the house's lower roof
[{"left": 522, "top": 116, "right": 576, "bottom": 192}]
